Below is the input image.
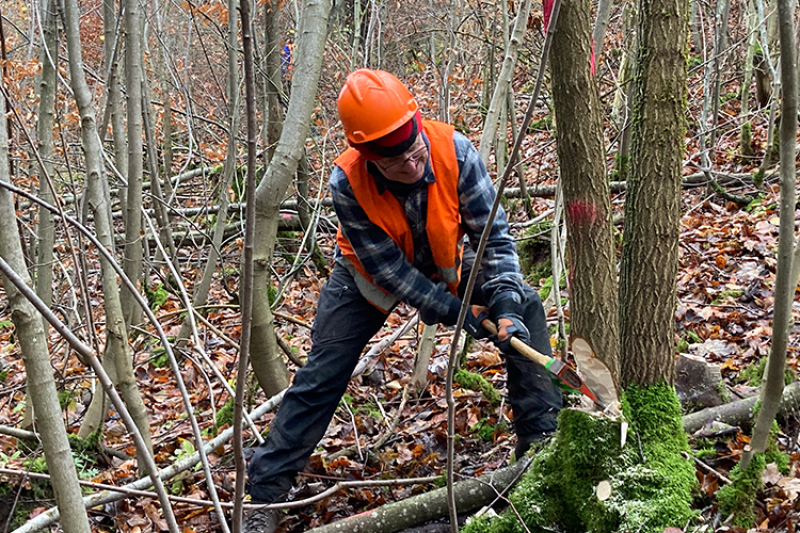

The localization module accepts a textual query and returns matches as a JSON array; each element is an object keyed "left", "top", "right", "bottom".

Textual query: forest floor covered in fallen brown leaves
[{"left": 0, "top": 164, "right": 800, "bottom": 533}]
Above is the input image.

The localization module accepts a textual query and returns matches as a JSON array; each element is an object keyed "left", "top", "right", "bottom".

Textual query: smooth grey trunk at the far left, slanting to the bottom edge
[{"left": 0, "top": 62, "right": 91, "bottom": 533}]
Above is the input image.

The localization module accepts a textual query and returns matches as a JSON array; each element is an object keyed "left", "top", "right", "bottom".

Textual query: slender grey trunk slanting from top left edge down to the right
[{"left": 64, "top": 0, "right": 152, "bottom": 458}]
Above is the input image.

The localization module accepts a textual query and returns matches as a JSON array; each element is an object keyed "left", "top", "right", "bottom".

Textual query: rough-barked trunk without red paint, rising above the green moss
[{"left": 620, "top": 0, "right": 689, "bottom": 387}]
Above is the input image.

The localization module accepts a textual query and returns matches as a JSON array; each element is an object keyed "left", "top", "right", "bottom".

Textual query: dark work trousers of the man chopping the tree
[{"left": 247, "top": 254, "right": 561, "bottom": 503}]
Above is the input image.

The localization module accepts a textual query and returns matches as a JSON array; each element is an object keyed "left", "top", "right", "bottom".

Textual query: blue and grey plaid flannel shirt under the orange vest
[{"left": 330, "top": 132, "right": 523, "bottom": 317}]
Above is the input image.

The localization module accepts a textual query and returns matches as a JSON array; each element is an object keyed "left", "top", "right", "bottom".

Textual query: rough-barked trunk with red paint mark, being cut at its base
[{"left": 550, "top": 1, "right": 619, "bottom": 376}]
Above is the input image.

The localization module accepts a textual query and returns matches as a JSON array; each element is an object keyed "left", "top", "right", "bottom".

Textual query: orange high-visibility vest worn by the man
[{"left": 334, "top": 120, "right": 464, "bottom": 312}]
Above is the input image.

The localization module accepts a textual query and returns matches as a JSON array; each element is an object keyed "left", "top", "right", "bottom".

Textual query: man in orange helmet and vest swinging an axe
[{"left": 245, "top": 69, "right": 561, "bottom": 533}]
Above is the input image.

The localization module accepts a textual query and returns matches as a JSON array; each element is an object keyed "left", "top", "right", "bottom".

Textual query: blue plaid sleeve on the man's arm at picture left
[{"left": 330, "top": 167, "right": 461, "bottom": 324}]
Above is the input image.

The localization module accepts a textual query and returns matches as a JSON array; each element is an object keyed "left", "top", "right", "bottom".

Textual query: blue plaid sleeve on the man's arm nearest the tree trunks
[{"left": 453, "top": 132, "right": 524, "bottom": 306}]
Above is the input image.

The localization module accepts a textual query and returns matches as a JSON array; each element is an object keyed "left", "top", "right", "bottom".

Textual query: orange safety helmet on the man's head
[{"left": 336, "top": 68, "right": 419, "bottom": 144}]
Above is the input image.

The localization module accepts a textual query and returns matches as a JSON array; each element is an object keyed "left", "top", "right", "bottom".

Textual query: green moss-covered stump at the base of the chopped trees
[{"left": 464, "top": 385, "right": 695, "bottom": 533}]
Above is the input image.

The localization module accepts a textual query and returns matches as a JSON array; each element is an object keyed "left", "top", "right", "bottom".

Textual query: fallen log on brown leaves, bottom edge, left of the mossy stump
[{"left": 307, "top": 458, "right": 531, "bottom": 533}]
